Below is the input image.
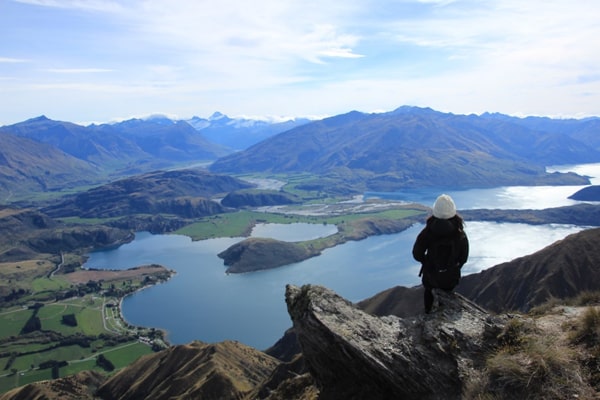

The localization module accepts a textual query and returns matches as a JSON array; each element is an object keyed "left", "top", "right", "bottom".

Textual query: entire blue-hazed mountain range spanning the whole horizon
[{"left": 0, "top": 107, "right": 600, "bottom": 201}]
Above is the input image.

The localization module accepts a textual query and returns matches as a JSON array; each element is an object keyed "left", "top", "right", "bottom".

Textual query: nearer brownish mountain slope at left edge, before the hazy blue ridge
[{"left": 0, "top": 132, "right": 99, "bottom": 201}]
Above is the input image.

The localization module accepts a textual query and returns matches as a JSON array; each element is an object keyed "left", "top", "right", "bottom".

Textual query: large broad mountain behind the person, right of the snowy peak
[{"left": 210, "top": 107, "right": 600, "bottom": 190}]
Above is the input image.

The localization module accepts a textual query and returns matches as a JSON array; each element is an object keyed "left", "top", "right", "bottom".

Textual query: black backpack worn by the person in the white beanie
[{"left": 423, "top": 234, "right": 461, "bottom": 290}]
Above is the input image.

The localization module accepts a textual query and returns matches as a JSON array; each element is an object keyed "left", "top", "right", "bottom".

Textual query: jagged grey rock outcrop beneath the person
[{"left": 286, "top": 285, "right": 503, "bottom": 400}]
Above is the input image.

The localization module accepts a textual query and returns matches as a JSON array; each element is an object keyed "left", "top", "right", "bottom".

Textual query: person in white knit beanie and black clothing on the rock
[{"left": 413, "top": 194, "right": 469, "bottom": 313}]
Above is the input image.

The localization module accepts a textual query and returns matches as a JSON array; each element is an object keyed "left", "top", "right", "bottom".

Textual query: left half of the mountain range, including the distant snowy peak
[{"left": 0, "top": 113, "right": 303, "bottom": 201}]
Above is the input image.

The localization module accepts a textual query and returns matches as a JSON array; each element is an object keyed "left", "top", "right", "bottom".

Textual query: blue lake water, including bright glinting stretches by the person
[{"left": 85, "top": 164, "right": 600, "bottom": 349}]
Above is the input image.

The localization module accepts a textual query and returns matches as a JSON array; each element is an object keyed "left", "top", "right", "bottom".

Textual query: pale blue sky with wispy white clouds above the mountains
[{"left": 0, "top": 0, "right": 600, "bottom": 125}]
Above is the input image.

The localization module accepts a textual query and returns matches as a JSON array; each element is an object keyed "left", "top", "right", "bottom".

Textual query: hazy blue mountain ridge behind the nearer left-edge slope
[{"left": 0, "top": 116, "right": 229, "bottom": 177}]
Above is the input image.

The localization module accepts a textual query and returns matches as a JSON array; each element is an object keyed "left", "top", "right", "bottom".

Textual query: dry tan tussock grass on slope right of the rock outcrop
[{"left": 464, "top": 294, "right": 600, "bottom": 400}]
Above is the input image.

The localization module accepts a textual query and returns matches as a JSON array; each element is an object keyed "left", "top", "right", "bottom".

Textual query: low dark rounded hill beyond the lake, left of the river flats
[{"left": 44, "top": 169, "right": 252, "bottom": 218}]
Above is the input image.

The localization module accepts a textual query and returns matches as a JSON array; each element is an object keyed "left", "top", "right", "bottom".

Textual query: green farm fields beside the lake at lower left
[{"left": 0, "top": 266, "right": 166, "bottom": 393}]
